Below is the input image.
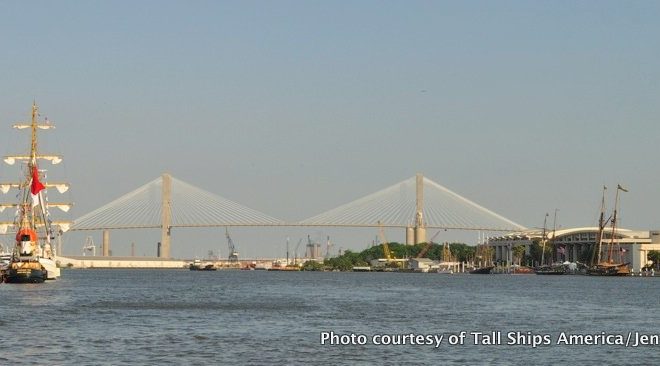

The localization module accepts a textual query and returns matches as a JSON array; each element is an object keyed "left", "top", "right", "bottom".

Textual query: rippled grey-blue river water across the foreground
[{"left": 0, "top": 269, "right": 660, "bottom": 365}]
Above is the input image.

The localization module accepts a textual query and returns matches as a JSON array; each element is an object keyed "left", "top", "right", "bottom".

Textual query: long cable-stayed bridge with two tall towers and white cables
[{"left": 72, "top": 174, "right": 525, "bottom": 258}]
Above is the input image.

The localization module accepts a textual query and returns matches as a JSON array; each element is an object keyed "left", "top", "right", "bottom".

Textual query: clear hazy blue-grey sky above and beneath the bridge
[{"left": 0, "top": 0, "right": 660, "bottom": 258}]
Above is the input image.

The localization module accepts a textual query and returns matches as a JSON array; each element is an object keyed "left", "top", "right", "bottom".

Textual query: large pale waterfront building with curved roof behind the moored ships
[{"left": 488, "top": 227, "right": 660, "bottom": 273}]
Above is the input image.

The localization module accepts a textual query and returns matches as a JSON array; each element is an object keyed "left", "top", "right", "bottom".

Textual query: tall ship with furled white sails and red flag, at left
[{"left": 0, "top": 103, "right": 72, "bottom": 283}]
